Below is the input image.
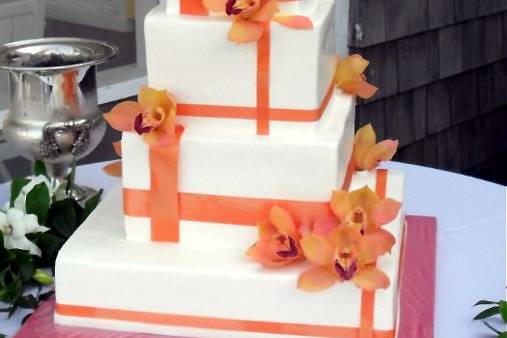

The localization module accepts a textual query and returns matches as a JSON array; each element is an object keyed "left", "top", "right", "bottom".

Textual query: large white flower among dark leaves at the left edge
[{"left": 0, "top": 208, "right": 49, "bottom": 257}]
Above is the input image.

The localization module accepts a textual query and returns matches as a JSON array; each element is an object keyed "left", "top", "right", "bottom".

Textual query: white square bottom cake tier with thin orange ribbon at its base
[{"left": 55, "top": 171, "right": 404, "bottom": 338}]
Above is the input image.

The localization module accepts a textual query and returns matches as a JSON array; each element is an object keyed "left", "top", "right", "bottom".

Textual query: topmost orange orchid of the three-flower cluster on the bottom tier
[{"left": 330, "top": 186, "right": 401, "bottom": 234}]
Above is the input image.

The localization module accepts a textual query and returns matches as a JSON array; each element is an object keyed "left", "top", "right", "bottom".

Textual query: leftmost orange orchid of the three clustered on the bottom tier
[{"left": 246, "top": 205, "right": 303, "bottom": 268}]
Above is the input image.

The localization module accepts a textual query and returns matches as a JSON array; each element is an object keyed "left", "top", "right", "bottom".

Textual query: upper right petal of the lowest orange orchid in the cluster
[{"left": 359, "top": 229, "right": 396, "bottom": 264}]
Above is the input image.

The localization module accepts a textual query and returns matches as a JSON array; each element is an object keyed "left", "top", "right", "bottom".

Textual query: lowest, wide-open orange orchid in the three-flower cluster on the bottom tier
[{"left": 298, "top": 225, "right": 395, "bottom": 292}]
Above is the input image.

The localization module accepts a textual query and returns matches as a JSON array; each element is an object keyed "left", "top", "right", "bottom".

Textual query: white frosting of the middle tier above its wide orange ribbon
[{"left": 122, "top": 92, "right": 354, "bottom": 202}]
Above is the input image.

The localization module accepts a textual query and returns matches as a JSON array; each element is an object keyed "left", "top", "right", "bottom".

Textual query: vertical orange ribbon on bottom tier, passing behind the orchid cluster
[{"left": 359, "top": 169, "right": 387, "bottom": 338}]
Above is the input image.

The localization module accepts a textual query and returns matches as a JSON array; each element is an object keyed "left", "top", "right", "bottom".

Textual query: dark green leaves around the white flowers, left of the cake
[{"left": 0, "top": 162, "right": 102, "bottom": 320}]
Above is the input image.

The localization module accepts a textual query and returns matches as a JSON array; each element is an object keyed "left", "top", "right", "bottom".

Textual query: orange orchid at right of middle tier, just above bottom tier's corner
[{"left": 354, "top": 124, "right": 399, "bottom": 170}]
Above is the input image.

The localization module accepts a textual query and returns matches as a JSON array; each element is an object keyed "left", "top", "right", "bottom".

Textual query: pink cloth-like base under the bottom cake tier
[{"left": 15, "top": 216, "right": 437, "bottom": 338}]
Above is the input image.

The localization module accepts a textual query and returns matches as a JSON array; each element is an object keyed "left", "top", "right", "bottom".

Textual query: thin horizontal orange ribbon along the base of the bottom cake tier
[{"left": 56, "top": 304, "right": 395, "bottom": 338}]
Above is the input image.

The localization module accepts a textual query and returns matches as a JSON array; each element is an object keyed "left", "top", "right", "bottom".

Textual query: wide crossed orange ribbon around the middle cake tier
[{"left": 123, "top": 152, "right": 354, "bottom": 235}]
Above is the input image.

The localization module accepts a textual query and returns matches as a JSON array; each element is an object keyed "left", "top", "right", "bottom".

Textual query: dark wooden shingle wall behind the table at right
[{"left": 349, "top": 0, "right": 507, "bottom": 184}]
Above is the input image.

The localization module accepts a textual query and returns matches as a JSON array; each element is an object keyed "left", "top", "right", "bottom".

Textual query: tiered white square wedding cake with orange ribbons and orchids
[{"left": 55, "top": 0, "right": 404, "bottom": 338}]
